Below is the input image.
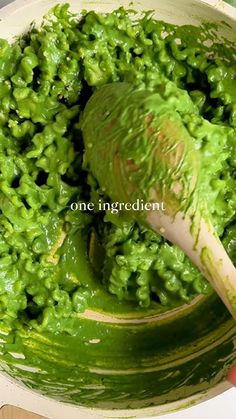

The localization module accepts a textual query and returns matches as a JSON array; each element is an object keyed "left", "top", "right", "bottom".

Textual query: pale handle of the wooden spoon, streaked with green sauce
[{"left": 147, "top": 211, "right": 236, "bottom": 320}]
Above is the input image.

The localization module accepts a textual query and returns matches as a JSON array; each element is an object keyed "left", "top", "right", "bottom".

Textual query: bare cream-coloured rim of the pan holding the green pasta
[{"left": 0, "top": 0, "right": 236, "bottom": 419}]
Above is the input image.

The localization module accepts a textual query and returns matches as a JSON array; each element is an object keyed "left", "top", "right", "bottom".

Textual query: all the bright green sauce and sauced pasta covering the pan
[{"left": 0, "top": 5, "right": 236, "bottom": 407}]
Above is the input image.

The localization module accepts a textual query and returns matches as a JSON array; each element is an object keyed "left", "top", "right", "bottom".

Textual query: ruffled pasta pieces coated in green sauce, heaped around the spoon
[{"left": 0, "top": 6, "right": 236, "bottom": 330}]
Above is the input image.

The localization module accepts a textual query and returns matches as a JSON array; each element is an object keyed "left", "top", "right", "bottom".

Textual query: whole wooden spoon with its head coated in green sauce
[{"left": 81, "top": 83, "right": 236, "bottom": 319}]
